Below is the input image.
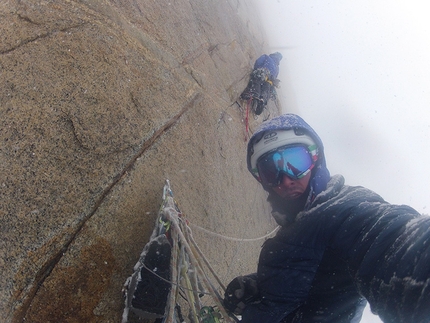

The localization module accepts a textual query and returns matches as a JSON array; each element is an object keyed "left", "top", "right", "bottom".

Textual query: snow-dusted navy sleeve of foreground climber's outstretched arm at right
[{"left": 332, "top": 190, "right": 430, "bottom": 323}]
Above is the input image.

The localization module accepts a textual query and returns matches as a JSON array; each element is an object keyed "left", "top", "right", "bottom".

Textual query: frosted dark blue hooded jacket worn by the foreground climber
[{"left": 242, "top": 116, "right": 430, "bottom": 323}]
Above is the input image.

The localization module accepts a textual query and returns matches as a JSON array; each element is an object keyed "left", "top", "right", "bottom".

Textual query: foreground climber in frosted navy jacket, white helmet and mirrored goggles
[{"left": 224, "top": 114, "right": 430, "bottom": 323}]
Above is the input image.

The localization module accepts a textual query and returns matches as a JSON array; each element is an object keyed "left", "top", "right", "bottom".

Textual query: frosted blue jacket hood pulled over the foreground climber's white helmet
[{"left": 247, "top": 114, "right": 330, "bottom": 197}]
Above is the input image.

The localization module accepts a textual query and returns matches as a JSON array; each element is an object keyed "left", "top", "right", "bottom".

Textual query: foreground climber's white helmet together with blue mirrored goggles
[{"left": 250, "top": 129, "right": 318, "bottom": 187}]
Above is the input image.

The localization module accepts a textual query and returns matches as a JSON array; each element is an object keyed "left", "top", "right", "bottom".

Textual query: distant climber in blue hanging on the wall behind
[{"left": 240, "top": 52, "right": 282, "bottom": 115}]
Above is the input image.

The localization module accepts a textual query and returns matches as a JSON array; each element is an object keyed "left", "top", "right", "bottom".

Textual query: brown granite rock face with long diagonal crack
[{"left": 0, "top": 0, "right": 278, "bottom": 322}]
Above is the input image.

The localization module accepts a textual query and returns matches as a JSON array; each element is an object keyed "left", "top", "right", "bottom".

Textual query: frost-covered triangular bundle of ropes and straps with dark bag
[{"left": 122, "top": 180, "right": 237, "bottom": 323}]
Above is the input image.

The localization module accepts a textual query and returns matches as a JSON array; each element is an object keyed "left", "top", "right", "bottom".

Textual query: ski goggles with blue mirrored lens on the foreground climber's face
[{"left": 257, "top": 145, "right": 318, "bottom": 187}]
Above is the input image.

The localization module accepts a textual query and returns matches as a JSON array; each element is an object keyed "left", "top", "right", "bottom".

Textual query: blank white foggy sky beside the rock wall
[{"left": 257, "top": 0, "right": 430, "bottom": 323}]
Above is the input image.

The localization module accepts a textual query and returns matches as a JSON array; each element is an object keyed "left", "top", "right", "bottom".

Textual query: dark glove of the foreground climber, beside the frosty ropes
[{"left": 224, "top": 274, "right": 260, "bottom": 315}]
